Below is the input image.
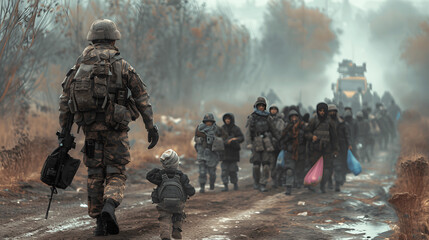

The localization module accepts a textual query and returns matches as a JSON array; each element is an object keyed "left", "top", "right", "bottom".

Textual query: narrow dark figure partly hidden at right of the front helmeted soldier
[{"left": 269, "top": 105, "right": 286, "bottom": 188}]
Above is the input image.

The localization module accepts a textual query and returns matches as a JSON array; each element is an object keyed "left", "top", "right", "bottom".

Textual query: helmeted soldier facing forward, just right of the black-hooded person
[{"left": 246, "top": 97, "right": 279, "bottom": 192}]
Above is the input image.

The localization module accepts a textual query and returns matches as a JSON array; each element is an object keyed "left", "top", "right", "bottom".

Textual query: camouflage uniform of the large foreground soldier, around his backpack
[{"left": 59, "top": 43, "right": 154, "bottom": 218}]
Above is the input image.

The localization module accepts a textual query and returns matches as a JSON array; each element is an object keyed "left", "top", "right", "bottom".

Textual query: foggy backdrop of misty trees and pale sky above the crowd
[{"left": 0, "top": 0, "right": 429, "bottom": 116}]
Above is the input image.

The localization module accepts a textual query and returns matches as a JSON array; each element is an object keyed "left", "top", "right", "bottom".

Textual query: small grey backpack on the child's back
[{"left": 158, "top": 173, "right": 186, "bottom": 213}]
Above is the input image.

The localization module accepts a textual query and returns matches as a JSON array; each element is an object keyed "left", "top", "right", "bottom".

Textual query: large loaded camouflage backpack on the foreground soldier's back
[{"left": 69, "top": 48, "right": 131, "bottom": 128}]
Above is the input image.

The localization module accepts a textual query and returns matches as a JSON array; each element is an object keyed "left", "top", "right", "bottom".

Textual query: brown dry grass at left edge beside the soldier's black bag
[{"left": 0, "top": 104, "right": 58, "bottom": 184}]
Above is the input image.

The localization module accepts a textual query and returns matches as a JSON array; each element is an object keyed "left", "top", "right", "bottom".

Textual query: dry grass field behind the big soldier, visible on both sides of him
[{"left": 0, "top": 99, "right": 249, "bottom": 184}]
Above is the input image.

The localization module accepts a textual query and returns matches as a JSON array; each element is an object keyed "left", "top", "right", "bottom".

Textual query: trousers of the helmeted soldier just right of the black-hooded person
[{"left": 250, "top": 151, "right": 273, "bottom": 185}]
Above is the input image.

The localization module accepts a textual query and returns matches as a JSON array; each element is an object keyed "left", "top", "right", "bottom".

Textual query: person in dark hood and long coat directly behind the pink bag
[{"left": 305, "top": 102, "right": 338, "bottom": 193}]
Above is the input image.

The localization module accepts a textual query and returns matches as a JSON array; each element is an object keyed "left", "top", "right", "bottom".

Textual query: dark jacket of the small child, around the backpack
[{"left": 146, "top": 168, "right": 195, "bottom": 202}]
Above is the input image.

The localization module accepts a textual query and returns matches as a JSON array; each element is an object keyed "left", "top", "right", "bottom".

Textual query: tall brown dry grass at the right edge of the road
[{"left": 389, "top": 111, "right": 429, "bottom": 240}]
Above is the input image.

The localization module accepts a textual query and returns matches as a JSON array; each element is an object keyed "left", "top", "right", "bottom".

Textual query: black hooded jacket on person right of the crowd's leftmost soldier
[{"left": 222, "top": 113, "right": 244, "bottom": 162}]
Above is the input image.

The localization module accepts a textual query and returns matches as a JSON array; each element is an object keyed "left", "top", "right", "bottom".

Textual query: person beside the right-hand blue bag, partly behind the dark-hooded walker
[{"left": 328, "top": 104, "right": 352, "bottom": 192}]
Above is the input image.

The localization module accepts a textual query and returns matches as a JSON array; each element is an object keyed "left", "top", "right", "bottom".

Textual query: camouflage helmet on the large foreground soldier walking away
[{"left": 86, "top": 19, "right": 121, "bottom": 41}]
